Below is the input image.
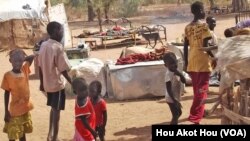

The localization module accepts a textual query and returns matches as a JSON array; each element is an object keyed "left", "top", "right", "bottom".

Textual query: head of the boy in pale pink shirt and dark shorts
[{"left": 47, "top": 22, "right": 63, "bottom": 42}]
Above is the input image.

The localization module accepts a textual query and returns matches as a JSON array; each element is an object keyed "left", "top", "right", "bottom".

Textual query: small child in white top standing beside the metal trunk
[{"left": 163, "top": 52, "right": 186, "bottom": 125}]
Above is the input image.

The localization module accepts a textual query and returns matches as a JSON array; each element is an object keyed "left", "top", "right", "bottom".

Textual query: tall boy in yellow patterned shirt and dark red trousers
[{"left": 184, "top": 1, "right": 214, "bottom": 124}]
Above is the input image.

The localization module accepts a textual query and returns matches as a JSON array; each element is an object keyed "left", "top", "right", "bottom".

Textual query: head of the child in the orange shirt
[{"left": 9, "top": 48, "right": 26, "bottom": 70}]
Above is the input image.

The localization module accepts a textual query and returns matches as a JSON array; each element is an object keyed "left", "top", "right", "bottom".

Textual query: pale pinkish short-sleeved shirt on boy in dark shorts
[{"left": 38, "top": 39, "right": 70, "bottom": 92}]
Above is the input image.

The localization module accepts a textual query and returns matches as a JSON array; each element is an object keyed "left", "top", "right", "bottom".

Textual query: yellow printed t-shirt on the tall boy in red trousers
[{"left": 185, "top": 21, "right": 212, "bottom": 72}]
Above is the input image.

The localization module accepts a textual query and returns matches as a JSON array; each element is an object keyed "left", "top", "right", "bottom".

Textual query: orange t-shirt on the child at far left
[{"left": 1, "top": 61, "right": 33, "bottom": 117}]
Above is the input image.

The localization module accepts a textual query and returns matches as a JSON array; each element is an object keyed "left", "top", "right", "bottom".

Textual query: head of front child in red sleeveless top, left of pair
[{"left": 72, "top": 77, "right": 88, "bottom": 99}]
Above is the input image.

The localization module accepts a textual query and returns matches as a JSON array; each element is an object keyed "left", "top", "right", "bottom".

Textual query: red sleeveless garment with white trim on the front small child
[{"left": 75, "top": 98, "right": 96, "bottom": 141}]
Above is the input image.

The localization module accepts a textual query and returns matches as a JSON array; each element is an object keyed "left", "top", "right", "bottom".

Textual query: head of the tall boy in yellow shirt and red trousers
[{"left": 191, "top": 1, "right": 205, "bottom": 19}]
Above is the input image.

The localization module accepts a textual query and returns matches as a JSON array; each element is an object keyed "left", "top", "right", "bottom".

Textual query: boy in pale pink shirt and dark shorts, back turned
[{"left": 38, "top": 22, "right": 71, "bottom": 141}]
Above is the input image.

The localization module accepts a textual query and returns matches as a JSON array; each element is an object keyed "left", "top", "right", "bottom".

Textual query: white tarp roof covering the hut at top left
[{"left": 0, "top": 0, "right": 45, "bottom": 21}]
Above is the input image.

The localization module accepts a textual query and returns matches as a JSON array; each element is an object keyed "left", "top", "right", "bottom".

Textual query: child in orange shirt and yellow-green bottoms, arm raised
[{"left": 1, "top": 49, "right": 34, "bottom": 141}]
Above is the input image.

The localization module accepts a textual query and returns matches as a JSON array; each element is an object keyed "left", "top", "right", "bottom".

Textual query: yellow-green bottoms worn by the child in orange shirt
[{"left": 3, "top": 112, "right": 33, "bottom": 140}]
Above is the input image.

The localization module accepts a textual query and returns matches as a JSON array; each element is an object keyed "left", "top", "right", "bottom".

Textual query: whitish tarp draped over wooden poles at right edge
[{"left": 216, "top": 35, "right": 250, "bottom": 91}]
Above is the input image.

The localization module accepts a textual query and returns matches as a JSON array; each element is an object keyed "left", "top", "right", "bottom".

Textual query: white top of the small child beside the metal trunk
[{"left": 165, "top": 68, "right": 181, "bottom": 103}]
